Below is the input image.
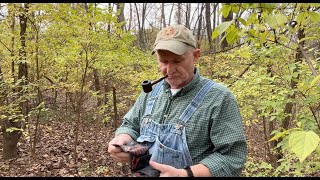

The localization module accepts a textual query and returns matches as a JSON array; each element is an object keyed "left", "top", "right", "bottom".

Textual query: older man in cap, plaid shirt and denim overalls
[{"left": 108, "top": 25, "right": 247, "bottom": 177}]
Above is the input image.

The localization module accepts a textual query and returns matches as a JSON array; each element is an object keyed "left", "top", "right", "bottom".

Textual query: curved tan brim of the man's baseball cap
[{"left": 151, "top": 40, "right": 188, "bottom": 55}]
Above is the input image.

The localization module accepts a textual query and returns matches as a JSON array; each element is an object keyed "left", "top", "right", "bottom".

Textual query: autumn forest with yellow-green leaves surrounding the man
[{"left": 0, "top": 3, "right": 320, "bottom": 177}]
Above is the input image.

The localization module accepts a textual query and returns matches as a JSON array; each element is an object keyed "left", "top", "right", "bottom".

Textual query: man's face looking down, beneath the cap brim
[{"left": 157, "top": 49, "right": 200, "bottom": 89}]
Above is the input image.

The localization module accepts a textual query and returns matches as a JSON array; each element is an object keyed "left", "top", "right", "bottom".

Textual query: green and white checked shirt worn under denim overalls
[{"left": 116, "top": 69, "right": 247, "bottom": 176}]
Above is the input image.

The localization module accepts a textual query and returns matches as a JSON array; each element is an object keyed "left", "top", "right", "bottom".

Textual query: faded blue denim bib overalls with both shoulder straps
[{"left": 137, "top": 80, "right": 214, "bottom": 169}]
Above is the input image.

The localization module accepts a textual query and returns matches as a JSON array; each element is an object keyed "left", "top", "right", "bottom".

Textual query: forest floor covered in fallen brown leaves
[{"left": 0, "top": 115, "right": 318, "bottom": 177}]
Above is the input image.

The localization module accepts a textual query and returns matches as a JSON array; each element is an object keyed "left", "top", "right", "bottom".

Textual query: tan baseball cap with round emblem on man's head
[{"left": 152, "top": 25, "right": 197, "bottom": 55}]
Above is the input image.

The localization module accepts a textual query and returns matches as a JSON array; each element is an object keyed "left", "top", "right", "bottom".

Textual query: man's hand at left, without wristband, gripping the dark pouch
[{"left": 108, "top": 134, "right": 133, "bottom": 162}]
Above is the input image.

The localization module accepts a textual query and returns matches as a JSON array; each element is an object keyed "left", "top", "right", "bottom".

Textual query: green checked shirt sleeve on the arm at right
[{"left": 199, "top": 93, "right": 247, "bottom": 177}]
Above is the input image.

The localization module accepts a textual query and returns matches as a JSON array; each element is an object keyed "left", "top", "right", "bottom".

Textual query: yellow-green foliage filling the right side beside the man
[{"left": 210, "top": 3, "right": 320, "bottom": 176}]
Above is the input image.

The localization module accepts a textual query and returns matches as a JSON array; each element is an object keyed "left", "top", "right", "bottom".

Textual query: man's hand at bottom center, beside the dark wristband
[{"left": 149, "top": 160, "right": 188, "bottom": 177}]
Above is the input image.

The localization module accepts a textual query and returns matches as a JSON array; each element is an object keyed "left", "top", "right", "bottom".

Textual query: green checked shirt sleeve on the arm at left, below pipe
[{"left": 115, "top": 92, "right": 146, "bottom": 140}]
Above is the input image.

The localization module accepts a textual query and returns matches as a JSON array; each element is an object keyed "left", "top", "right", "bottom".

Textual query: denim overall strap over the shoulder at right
[{"left": 179, "top": 80, "right": 214, "bottom": 123}]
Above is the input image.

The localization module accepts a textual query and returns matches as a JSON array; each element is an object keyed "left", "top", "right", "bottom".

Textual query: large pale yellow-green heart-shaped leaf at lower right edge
[{"left": 289, "top": 131, "right": 320, "bottom": 163}]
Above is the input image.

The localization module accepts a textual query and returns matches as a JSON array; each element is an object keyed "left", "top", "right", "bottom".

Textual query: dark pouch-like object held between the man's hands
[{"left": 112, "top": 141, "right": 160, "bottom": 177}]
